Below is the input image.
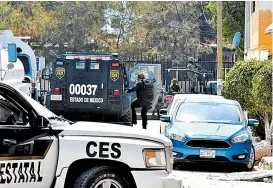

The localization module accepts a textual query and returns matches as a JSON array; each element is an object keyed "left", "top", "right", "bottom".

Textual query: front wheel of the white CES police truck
[{"left": 73, "top": 166, "right": 131, "bottom": 188}]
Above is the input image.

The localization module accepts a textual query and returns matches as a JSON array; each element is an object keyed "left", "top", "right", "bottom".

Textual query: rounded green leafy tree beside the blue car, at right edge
[{"left": 224, "top": 59, "right": 272, "bottom": 140}]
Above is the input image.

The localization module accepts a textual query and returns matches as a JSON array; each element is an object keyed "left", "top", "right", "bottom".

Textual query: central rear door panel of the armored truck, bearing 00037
[{"left": 67, "top": 57, "right": 110, "bottom": 111}]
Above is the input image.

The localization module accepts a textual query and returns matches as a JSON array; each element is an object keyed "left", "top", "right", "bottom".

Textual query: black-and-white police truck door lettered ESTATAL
[{"left": 0, "top": 86, "right": 59, "bottom": 188}]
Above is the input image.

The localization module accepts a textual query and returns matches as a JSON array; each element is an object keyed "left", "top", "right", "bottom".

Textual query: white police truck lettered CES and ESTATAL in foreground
[{"left": 0, "top": 82, "right": 182, "bottom": 188}]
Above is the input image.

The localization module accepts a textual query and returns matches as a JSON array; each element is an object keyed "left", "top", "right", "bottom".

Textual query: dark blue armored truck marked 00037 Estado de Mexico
[{"left": 47, "top": 53, "right": 131, "bottom": 123}]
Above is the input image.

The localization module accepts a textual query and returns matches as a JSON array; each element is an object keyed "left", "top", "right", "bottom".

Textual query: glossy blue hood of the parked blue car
[{"left": 173, "top": 122, "right": 244, "bottom": 138}]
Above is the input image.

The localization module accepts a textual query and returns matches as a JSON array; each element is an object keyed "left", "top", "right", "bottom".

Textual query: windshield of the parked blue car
[{"left": 176, "top": 103, "right": 242, "bottom": 124}]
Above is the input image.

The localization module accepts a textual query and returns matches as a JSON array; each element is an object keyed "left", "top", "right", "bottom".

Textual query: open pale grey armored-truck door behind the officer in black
[{"left": 128, "top": 64, "right": 162, "bottom": 111}]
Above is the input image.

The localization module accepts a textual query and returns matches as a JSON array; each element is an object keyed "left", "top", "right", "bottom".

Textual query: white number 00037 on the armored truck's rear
[{"left": 69, "top": 84, "right": 98, "bottom": 95}]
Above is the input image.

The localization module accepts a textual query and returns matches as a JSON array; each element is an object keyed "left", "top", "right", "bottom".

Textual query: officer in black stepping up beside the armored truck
[{"left": 128, "top": 73, "right": 151, "bottom": 129}]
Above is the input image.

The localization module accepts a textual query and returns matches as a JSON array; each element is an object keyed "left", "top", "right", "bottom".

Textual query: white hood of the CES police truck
[{"left": 54, "top": 121, "right": 172, "bottom": 147}]
